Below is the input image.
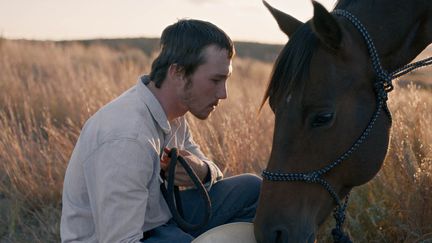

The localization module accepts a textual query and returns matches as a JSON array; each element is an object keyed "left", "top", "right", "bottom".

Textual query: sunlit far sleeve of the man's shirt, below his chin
[{"left": 184, "top": 122, "right": 223, "bottom": 190}]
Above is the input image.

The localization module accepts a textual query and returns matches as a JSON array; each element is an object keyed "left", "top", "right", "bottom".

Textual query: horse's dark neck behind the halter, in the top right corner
[{"left": 337, "top": 0, "right": 432, "bottom": 72}]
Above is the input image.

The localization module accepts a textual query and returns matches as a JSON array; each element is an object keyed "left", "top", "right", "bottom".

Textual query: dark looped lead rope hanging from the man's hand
[{"left": 160, "top": 148, "right": 212, "bottom": 232}]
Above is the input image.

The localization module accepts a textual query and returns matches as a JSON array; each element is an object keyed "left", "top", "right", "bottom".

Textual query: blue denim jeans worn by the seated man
[{"left": 144, "top": 174, "right": 261, "bottom": 243}]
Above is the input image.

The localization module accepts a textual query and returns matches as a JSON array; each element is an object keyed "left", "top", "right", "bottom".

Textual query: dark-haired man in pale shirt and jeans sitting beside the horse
[{"left": 60, "top": 20, "right": 261, "bottom": 243}]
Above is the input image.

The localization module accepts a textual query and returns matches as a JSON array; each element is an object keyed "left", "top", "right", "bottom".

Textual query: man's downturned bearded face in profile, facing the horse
[{"left": 181, "top": 45, "right": 232, "bottom": 120}]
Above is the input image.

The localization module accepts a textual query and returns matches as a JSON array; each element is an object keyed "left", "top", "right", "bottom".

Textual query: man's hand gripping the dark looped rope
[{"left": 161, "top": 148, "right": 209, "bottom": 187}]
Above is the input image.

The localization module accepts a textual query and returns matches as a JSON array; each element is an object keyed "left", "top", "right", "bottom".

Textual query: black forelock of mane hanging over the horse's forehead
[{"left": 261, "top": 23, "right": 318, "bottom": 108}]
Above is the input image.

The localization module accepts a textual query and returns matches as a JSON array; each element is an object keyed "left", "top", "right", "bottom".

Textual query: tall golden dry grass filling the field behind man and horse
[{"left": 0, "top": 39, "right": 432, "bottom": 242}]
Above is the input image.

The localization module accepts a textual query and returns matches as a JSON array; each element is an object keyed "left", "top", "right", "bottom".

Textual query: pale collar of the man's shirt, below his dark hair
[{"left": 137, "top": 75, "right": 171, "bottom": 134}]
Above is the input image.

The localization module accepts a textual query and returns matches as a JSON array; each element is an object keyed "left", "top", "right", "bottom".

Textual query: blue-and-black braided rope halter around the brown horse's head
[{"left": 262, "top": 9, "right": 432, "bottom": 242}]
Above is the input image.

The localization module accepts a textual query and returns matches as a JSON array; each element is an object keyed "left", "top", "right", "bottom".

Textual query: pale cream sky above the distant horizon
[{"left": 0, "top": 0, "right": 336, "bottom": 44}]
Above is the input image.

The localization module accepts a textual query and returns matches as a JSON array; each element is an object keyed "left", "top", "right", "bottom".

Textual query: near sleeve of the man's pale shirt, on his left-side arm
[{"left": 84, "top": 139, "right": 157, "bottom": 243}]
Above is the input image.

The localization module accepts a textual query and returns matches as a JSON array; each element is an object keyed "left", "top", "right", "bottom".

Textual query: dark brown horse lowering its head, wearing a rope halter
[{"left": 254, "top": 0, "right": 432, "bottom": 243}]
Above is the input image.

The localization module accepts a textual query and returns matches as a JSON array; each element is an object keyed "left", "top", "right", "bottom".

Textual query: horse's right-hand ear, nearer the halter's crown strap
[{"left": 312, "top": 0, "right": 342, "bottom": 50}]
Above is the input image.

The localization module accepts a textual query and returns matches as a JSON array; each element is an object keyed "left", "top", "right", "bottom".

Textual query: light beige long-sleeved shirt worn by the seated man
[{"left": 60, "top": 76, "right": 222, "bottom": 242}]
